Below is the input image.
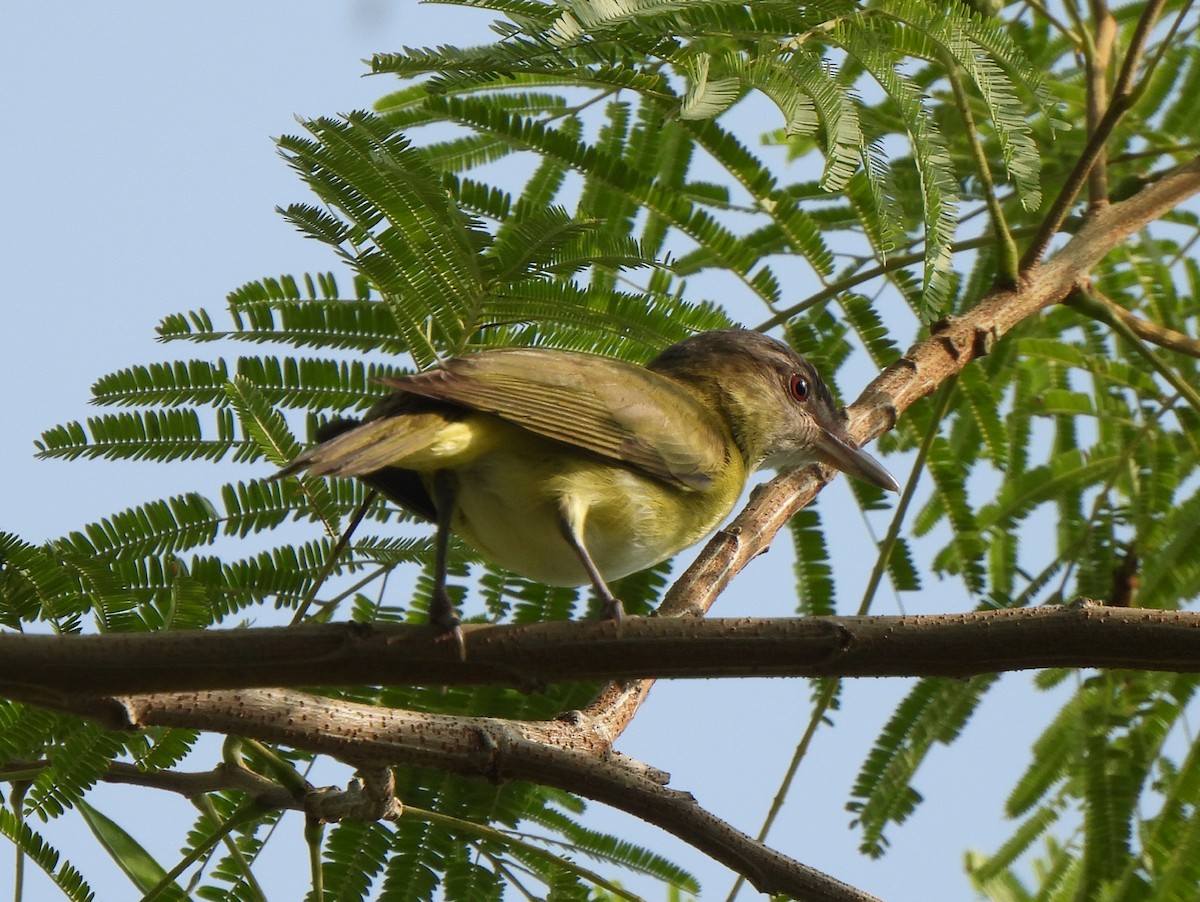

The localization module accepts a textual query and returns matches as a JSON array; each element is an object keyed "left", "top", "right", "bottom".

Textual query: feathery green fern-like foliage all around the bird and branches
[{"left": 7, "top": 0, "right": 1200, "bottom": 900}]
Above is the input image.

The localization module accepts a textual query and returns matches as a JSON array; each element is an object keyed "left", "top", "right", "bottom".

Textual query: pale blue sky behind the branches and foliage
[{"left": 0, "top": 0, "right": 1070, "bottom": 902}]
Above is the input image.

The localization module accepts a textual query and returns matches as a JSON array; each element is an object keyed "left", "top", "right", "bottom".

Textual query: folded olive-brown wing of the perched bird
[{"left": 385, "top": 348, "right": 730, "bottom": 489}]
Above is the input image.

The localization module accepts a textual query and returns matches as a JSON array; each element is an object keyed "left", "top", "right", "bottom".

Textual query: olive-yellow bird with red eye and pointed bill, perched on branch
[{"left": 276, "top": 329, "right": 899, "bottom": 656}]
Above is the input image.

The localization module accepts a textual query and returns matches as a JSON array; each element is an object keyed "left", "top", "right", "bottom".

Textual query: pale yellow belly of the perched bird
[{"left": 441, "top": 433, "right": 746, "bottom": 585}]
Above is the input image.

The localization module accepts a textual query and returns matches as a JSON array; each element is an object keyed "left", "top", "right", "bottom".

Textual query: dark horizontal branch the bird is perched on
[{"left": 7, "top": 602, "right": 1200, "bottom": 708}]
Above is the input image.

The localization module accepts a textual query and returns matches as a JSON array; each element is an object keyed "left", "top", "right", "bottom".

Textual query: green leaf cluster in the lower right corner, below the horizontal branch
[{"left": 970, "top": 672, "right": 1200, "bottom": 900}]
